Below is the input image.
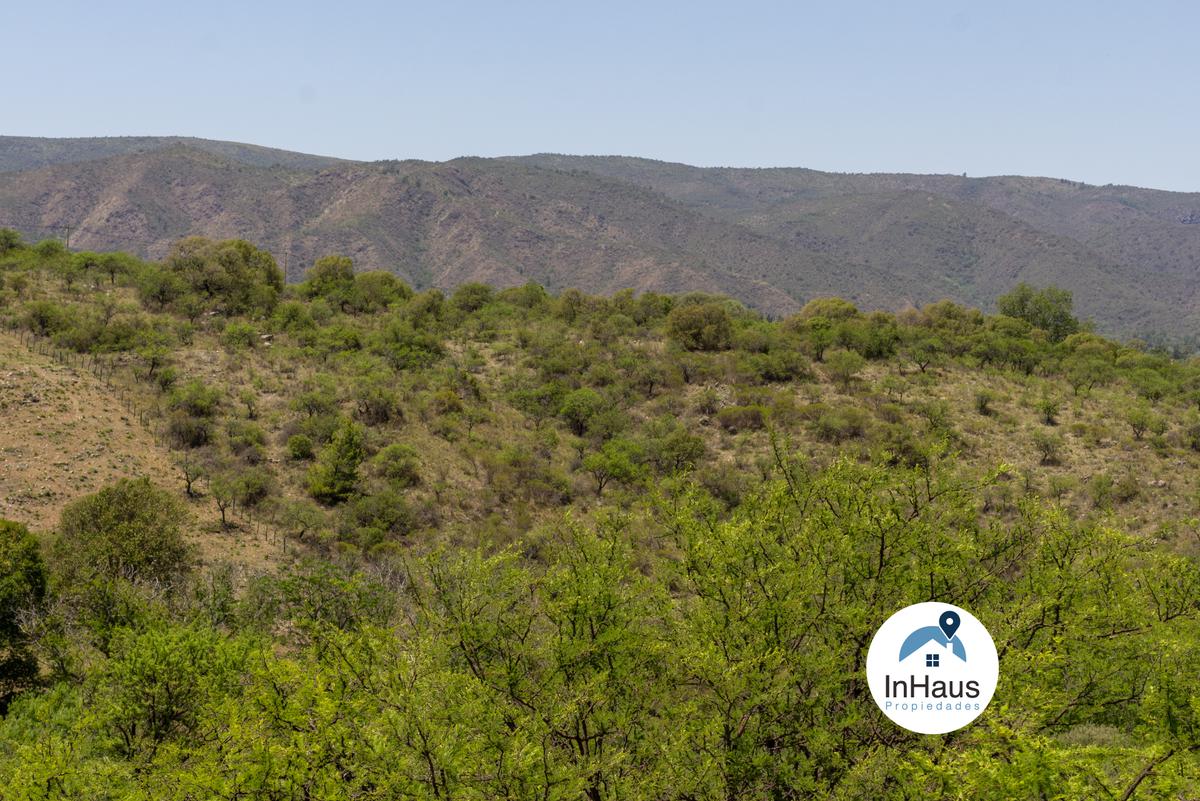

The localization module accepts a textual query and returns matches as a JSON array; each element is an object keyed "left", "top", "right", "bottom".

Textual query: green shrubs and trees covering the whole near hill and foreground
[{"left": 0, "top": 231, "right": 1200, "bottom": 800}]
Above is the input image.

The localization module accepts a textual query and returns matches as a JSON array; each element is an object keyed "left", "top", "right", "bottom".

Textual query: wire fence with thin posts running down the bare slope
[{"left": 12, "top": 327, "right": 292, "bottom": 555}]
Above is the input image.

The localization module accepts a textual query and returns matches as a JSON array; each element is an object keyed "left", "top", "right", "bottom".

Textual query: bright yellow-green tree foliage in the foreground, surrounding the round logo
[{"left": 0, "top": 460, "right": 1200, "bottom": 801}]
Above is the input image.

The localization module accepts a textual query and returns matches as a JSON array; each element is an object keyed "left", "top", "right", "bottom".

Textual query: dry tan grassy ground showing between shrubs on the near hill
[{"left": 2, "top": 268, "right": 1200, "bottom": 565}]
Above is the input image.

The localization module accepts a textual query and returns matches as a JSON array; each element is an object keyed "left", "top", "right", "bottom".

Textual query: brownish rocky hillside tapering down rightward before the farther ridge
[{"left": 0, "top": 146, "right": 868, "bottom": 314}]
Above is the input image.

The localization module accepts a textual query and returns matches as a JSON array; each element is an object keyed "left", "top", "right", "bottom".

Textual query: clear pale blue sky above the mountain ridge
[{"left": 9, "top": 0, "right": 1200, "bottom": 191}]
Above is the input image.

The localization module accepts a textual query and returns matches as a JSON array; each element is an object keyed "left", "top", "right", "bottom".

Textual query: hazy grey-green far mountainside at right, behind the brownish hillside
[{"left": 516, "top": 153, "right": 1200, "bottom": 335}]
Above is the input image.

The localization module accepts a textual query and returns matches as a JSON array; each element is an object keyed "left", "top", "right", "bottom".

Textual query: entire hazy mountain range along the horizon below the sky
[{"left": 0, "top": 137, "right": 1200, "bottom": 339}]
